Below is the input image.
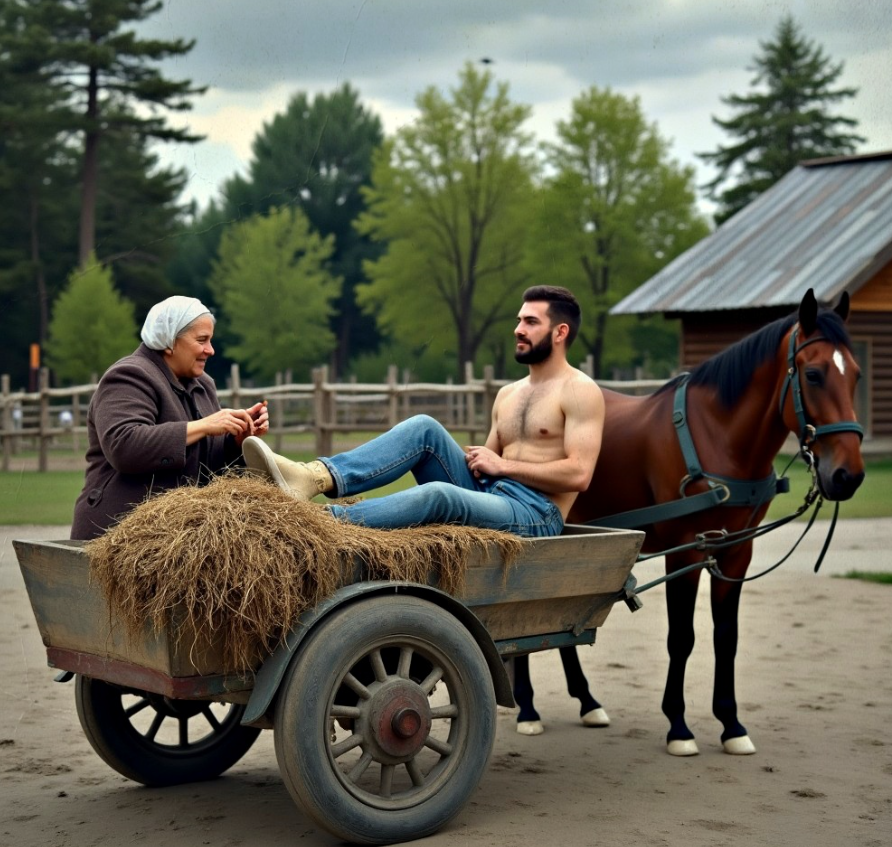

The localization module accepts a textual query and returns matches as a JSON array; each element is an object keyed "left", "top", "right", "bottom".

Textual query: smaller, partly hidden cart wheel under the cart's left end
[{"left": 75, "top": 676, "right": 260, "bottom": 786}]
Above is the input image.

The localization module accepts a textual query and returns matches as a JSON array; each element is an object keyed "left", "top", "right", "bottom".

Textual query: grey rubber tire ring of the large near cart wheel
[{"left": 274, "top": 595, "right": 496, "bottom": 844}]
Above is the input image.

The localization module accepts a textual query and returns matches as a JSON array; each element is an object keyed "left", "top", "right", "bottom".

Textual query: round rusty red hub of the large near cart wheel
[{"left": 359, "top": 679, "right": 431, "bottom": 764}]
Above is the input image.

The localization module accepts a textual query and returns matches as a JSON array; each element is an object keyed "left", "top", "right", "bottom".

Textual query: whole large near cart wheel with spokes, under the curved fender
[{"left": 275, "top": 595, "right": 495, "bottom": 844}]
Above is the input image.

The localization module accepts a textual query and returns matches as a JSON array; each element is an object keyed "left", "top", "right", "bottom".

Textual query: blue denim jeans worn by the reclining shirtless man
[{"left": 321, "top": 415, "right": 564, "bottom": 537}]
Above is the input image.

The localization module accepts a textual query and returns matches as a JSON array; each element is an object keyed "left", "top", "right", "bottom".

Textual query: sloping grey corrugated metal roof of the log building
[{"left": 610, "top": 151, "right": 892, "bottom": 314}]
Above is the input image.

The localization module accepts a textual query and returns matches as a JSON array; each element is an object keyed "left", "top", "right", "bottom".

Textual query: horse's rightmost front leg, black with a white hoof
[{"left": 711, "top": 557, "right": 756, "bottom": 755}]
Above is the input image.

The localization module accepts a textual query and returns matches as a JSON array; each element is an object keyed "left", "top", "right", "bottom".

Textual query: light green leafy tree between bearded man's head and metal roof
[{"left": 528, "top": 86, "right": 708, "bottom": 376}]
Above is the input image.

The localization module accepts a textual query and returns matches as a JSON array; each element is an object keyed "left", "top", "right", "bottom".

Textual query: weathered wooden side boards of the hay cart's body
[{"left": 13, "top": 527, "right": 643, "bottom": 690}]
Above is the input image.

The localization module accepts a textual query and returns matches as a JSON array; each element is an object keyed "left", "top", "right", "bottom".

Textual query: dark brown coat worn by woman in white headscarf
[{"left": 71, "top": 344, "right": 242, "bottom": 539}]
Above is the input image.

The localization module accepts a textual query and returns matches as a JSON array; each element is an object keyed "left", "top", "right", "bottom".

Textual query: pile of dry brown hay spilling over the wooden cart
[{"left": 86, "top": 474, "right": 524, "bottom": 671}]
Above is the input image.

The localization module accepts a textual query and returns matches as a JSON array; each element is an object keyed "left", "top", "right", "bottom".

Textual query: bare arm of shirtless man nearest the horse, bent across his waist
[{"left": 468, "top": 379, "right": 604, "bottom": 494}]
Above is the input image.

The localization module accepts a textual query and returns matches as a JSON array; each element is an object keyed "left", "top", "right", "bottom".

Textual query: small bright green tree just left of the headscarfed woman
[{"left": 47, "top": 256, "right": 139, "bottom": 384}]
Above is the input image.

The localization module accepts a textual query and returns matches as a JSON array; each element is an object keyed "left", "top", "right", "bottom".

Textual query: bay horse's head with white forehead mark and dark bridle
[{"left": 781, "top": 289, "right": 864, "bottom": 500}]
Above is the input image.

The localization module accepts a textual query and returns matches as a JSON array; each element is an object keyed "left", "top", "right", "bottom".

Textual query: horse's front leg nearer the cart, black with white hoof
[{"left": 663, "top": 557, "right": 700, "bottom": 756}]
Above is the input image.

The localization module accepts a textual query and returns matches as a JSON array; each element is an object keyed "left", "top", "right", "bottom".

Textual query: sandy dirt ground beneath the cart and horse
[{"left": 0, "top": 520, "right": 892, "bottom": 847}]
